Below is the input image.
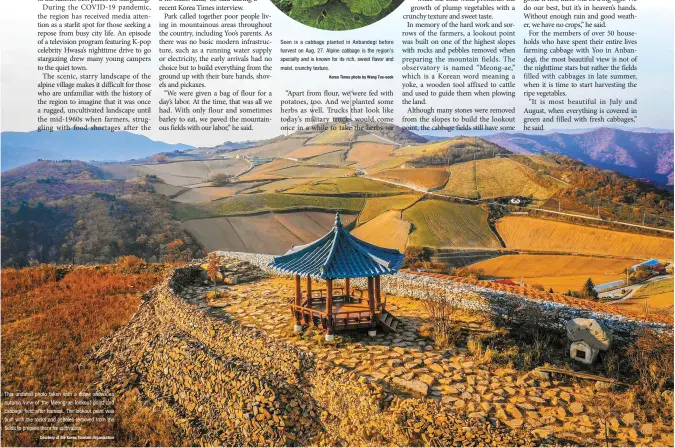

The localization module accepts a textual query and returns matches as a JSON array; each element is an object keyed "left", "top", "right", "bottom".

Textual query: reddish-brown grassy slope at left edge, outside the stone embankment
[{"left": 2, "top": 264, "right": 171, "bottom": 446}]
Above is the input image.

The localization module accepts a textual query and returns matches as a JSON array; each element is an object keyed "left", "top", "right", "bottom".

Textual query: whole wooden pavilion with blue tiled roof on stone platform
[{"left": 270, "top": 213, "right": 403, "bottom": 341}]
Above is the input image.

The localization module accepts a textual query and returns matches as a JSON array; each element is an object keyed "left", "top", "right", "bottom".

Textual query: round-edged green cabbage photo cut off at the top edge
[{"left": 272, "top": 0, "right": 403, "bottom": 31}]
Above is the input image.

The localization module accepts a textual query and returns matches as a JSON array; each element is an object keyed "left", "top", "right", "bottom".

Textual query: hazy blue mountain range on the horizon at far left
[{"left": 1, "top": 131, "right": 193, "bottom": 171}]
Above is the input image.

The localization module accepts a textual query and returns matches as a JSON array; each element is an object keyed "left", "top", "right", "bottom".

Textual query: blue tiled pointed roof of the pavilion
[{"left": 270, "top": 213, "right": 403, "bottom": 279}]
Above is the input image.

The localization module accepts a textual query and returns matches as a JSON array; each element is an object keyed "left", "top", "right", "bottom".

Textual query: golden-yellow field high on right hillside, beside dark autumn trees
[{"left": 442, "top": 158, "right": 561, "bottom": 200}]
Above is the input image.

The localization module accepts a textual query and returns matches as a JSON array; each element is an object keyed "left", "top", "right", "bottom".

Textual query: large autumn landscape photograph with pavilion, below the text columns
[{"left": 1, "top": 121, "right": 675, "bottom": 447}]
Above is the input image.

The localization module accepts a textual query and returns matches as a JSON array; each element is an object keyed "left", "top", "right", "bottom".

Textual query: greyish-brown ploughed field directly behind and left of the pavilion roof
[{"left": 183, "top": 212, "right": 355, "bottom": 255}]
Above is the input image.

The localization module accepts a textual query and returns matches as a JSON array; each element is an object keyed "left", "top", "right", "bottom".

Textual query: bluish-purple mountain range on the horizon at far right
[{"left": 483, "top": 128, "right": 673, "bottom": 185}]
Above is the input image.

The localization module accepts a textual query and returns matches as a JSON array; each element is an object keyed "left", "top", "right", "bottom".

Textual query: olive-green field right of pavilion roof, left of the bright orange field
[{"left": 403, "top": 199, "right": 501, "bottom": 249}]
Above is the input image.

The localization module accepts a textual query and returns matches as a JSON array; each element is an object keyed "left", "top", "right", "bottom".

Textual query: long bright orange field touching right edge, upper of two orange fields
[{"left": 497, "top": 216, "right": 673, "bottom": 260}]
